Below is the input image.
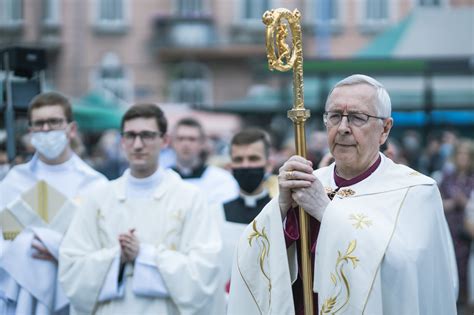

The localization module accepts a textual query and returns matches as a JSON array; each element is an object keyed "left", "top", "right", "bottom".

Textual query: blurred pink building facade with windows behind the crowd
[{"left": 0, "top": 0, "right": 473, "bottom": 108}]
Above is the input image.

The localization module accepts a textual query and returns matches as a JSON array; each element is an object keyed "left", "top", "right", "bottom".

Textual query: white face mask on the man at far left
[{"left": 31, "top": 130, "right": 68, "bottom": 160}]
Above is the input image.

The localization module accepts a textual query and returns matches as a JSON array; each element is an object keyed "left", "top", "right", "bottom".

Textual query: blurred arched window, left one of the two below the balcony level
[{"left": 94, "top": 52, "right": 133, "bottom": 102}]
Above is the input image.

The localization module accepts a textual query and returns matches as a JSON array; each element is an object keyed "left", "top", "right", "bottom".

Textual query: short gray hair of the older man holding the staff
[{"left": 325, "top": 74, "right": 392, "bottom": 118}]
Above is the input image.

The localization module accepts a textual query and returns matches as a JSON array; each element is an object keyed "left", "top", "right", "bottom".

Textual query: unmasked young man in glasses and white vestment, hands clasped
[{"left": 59, "top": 104, "right": 224, "bottom": 314}]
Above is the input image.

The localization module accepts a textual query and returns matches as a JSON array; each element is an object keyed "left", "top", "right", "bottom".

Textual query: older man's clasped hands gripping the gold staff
[{"left": 278, "top": 155, "right": 330, "bottom": 221}]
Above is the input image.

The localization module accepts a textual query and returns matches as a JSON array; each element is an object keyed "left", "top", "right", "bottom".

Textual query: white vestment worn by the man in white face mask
[{"left": 0, "top": 154, "right": 107, "bottom": 315}]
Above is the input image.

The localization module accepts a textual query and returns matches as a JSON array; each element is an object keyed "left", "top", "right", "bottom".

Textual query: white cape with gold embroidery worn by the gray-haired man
[{"left": 229, "top": 155, "right": 457, "bottom": 315}]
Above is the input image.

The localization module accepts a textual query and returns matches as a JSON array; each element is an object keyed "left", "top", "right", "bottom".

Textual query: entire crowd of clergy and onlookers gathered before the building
[{"left": 0, "top": 75, "right": 474, "bottom": 314}]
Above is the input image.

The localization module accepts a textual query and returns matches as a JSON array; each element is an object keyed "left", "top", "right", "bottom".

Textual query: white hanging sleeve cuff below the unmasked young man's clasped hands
[{"left": 132, "top": 244, "right": 169, "bottom": 298}]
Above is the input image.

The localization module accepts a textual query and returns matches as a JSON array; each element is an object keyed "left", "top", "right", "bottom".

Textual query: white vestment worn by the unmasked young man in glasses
[{"left": 59, "top": 170, "right": 222, "bottom": 314}]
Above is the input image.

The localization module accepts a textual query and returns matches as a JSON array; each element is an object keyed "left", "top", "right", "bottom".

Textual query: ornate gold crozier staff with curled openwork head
[{"left": 262, "top": 8, "right": 313, "bottom": 315}]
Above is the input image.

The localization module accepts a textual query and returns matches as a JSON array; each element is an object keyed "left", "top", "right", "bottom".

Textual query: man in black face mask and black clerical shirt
[{"left": 224, "top": 128, "right": 271, "bottom": 224}]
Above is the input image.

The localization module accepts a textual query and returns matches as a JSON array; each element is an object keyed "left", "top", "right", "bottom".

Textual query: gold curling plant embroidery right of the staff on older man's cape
[{"left": 319, "top": 240, "right": 359, "bottom": 315}]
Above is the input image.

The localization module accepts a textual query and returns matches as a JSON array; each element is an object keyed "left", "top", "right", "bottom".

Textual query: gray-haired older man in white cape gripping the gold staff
[{"left": 228, "top": 75, "right": 457, "bottom": 315}]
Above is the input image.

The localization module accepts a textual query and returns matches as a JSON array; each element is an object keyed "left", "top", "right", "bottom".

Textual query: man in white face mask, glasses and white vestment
[{"left": 0, "top": 92, "right": 106, "bottom": 314}]
